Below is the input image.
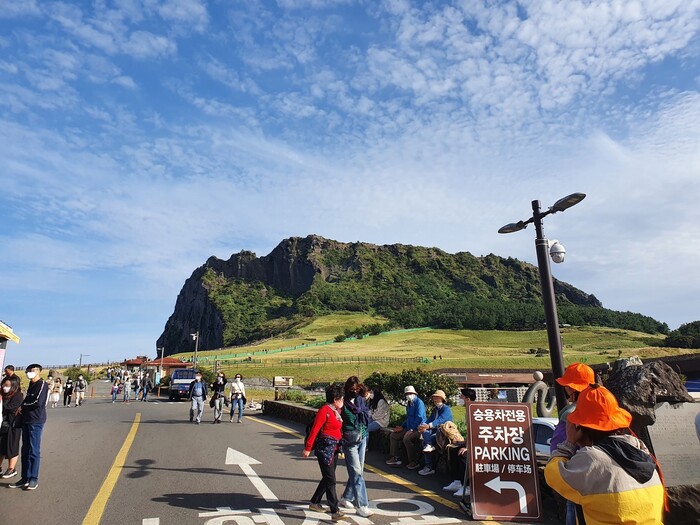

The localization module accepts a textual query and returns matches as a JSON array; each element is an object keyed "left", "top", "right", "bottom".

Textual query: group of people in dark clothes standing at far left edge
[{"left": 0, "top": 364, "right": 47, "bottom": 490}]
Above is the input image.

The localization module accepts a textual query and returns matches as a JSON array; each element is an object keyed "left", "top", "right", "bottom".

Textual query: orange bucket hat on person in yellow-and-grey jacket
[{"left": 568, "top": 384, "right": 632, "bottom": 432}]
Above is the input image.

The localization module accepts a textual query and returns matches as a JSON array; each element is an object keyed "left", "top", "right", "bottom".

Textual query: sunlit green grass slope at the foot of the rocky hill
[{"left": 168, "top": 313, "right": 693, "bottom": 385}]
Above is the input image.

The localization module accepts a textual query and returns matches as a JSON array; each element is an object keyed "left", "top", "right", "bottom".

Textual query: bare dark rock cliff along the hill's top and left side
[{"left": 156, "top": 235, "right": 601, "bottom": 355}]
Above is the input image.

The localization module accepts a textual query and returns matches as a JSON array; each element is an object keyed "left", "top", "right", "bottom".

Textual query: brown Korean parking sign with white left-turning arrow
[{"left": 467, "top": 403, "right": 542, "bottom": 521}]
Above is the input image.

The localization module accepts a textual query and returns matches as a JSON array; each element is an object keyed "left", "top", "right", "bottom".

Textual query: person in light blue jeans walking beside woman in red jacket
[{"left": 339, "top": 376, "right": 372, "bottom": 518}]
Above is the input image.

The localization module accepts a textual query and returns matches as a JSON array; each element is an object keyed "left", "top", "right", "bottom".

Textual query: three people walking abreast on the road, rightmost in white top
[{"left": 187, "top": 371, "right": 247, "bottom": 425}]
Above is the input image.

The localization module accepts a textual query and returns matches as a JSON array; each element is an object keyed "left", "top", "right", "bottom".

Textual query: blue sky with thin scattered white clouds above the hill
[{"left": 0, "top": 0, "right": 700, "bottom": 364}]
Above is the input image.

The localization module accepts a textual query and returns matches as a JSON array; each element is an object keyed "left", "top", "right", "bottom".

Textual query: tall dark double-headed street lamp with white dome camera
[{"left": 498, "top": 193, "right": 586, "bottom": 410}]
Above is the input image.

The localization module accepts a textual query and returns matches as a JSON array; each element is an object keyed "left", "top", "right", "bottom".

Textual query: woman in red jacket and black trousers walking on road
[{"left": 303, "top": 384, "right": 345, "bottom": 521}]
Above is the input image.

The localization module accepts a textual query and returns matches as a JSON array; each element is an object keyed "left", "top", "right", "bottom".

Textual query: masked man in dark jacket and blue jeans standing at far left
[{"left": 10, "top": 363, "right": 49, "bottom": 490}]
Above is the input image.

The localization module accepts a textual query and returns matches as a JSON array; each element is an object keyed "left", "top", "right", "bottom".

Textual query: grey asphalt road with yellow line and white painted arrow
[{"left": 0, "top": 384, "right": 556, "bottom": 525}]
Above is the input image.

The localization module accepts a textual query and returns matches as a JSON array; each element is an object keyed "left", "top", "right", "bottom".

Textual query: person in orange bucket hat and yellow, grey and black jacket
[{"left": 544, "top": 384, "right": 664, "bottom": 525}]
